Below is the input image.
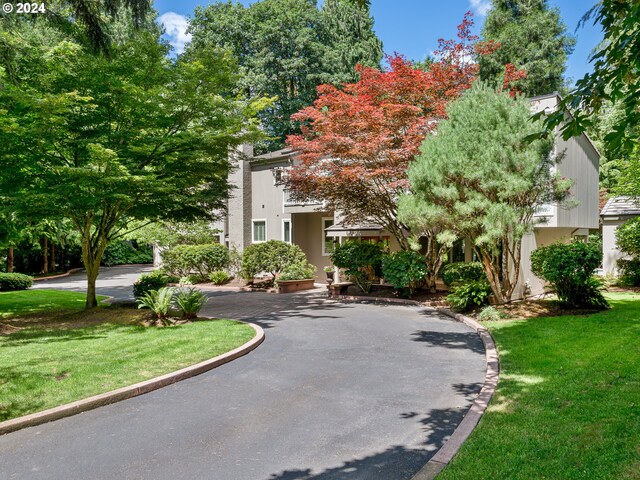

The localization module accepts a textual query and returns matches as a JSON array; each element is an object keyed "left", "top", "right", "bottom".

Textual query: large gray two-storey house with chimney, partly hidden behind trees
[{"left": 205, "top": 93, "right": 600, "bottom": 297}]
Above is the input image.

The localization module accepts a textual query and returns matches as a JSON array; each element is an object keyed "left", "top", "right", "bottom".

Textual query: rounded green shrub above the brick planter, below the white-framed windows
[{"left": 242, "top": 240, "right": 307, "bottom": 281}]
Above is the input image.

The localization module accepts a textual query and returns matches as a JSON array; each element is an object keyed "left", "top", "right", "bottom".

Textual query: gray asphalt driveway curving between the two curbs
[{"left": 0, "top": 268, "right": 485, "bottom": 480}]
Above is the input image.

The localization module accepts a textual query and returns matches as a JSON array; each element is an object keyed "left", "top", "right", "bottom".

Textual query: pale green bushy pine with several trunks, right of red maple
[{"left": 398, "top": 82, "right": 571, "bottom": 303}]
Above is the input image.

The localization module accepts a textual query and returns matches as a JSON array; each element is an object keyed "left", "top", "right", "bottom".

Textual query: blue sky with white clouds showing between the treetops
[{"left": 154, "top": 0, "right": 602, "bottom": 85}]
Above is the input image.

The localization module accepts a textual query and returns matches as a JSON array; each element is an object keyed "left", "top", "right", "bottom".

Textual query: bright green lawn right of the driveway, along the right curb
[{"left": 438, "top": 294, "right": 640, "bottom": 480}]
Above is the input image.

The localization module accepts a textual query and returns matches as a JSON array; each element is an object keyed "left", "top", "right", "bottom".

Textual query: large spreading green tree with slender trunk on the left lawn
[{"left": 0, "top": 16, "right": 269, "bottom": 306}]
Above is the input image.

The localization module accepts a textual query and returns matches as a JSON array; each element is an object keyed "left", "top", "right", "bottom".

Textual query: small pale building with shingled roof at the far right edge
[{"left": 600, "top": 197, "right": 640, "bottom": 275}]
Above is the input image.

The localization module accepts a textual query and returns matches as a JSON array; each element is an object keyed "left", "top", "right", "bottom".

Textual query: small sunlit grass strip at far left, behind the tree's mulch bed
[{"left": 0, "top": 290, "right": 107, "bottom": 319}]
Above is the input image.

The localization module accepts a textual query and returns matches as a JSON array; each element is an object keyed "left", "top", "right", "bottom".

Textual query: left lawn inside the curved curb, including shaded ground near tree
[{"left": 0, "top": 290, "right": 255, "bottom": 421}]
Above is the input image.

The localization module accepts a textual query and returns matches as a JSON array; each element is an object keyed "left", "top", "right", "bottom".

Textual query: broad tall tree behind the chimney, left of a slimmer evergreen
[{"left": 190, "top": 0, "right": 324, "bottom": 151}]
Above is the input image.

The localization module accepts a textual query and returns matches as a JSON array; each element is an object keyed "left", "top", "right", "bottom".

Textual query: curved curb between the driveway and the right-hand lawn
[{"left": 411, "top": 308, "right": 500, "bottom": 480}]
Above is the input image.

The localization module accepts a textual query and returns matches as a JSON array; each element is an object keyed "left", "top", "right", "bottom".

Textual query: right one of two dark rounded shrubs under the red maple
[{"left": 382, "top": 251, "right": 429, "bottom": 295}]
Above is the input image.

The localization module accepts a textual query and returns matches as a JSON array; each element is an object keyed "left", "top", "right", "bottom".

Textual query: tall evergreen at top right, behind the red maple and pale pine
[{"left": 479, "top": 0, "right": 575, "bottom": 96}]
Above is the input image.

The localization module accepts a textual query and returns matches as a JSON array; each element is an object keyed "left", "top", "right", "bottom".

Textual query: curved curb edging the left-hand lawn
[{"left": 0, "top": 323, "right": 264, "bottom": 435}]
